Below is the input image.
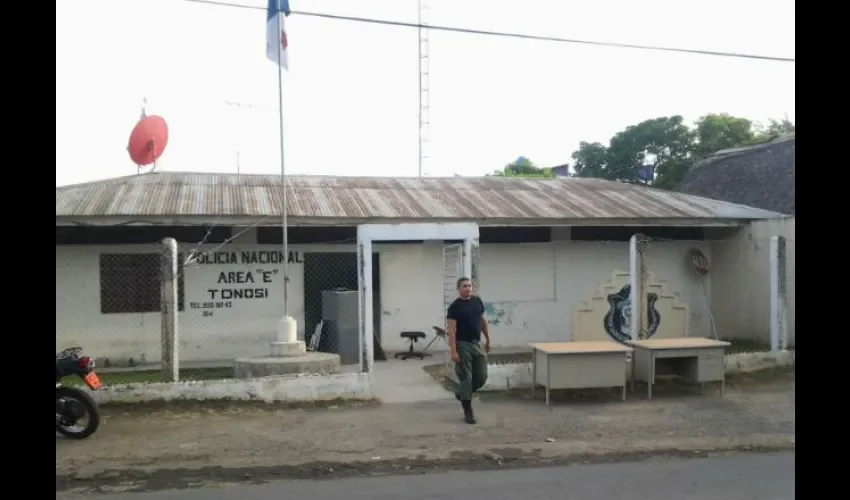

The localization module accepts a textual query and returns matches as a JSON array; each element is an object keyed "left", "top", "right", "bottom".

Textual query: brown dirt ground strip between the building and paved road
[{"left": 56, "top": 372, "right": 795, "bottom": 492}]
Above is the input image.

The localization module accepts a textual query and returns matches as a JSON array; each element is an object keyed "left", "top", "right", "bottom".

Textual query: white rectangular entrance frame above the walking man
[{"left": 357, "top": 222, "right": 478, "bottom": 373}]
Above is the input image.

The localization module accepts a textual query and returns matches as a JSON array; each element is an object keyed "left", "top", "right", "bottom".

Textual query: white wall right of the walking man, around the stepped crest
[{"left": 480, "top": 241, "right": 711, "bottom": 346}]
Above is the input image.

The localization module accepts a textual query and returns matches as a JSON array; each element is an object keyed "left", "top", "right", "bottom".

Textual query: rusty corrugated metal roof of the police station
[{"left": 56, "top": 172, "right": 779, "bottom": 222}]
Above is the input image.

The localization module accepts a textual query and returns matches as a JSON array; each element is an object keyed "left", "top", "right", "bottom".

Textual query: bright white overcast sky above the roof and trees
[{"left": 56, "top": 0, "right": 795, "bottom": 186}]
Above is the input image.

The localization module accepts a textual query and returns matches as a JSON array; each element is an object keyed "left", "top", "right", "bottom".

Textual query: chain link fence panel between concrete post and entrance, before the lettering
[{"left": 179, "top": 243, "right": 364, "bottom": 378}]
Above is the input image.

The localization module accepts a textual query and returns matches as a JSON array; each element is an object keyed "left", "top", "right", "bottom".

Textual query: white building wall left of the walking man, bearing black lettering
[{"left": 56, "top": 241, "right": 442, "bottom": 363}]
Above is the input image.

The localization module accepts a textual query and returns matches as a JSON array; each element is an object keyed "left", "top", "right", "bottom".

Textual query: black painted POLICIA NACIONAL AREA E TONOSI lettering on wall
[{"left": 189, "top": 250, "right": 304, "bottom": 317}]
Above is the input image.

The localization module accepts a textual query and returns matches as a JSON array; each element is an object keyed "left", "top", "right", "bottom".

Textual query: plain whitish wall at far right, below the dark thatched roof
[{"left": 711, "top": 217, "right": 796, "bottom": 345}]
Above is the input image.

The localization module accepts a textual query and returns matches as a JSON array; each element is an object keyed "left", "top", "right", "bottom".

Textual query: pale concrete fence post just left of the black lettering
[{"left": 160, "top": 238, "right": 180, "bottom": 382}]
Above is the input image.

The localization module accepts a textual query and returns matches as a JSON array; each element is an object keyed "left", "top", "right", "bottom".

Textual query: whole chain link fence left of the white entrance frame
[{"left": 56, "top": 236, "right": 370, "bottom": 383}]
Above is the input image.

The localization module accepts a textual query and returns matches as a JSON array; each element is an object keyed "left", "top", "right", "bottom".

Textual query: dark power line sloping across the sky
[{"left": 185, "top": 0, "right": 797, "bottom": 63}]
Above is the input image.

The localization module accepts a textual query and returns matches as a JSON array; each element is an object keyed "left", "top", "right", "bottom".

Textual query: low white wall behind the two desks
[{"left": 474, "top": 351, "right": 795, "bottom": 391}]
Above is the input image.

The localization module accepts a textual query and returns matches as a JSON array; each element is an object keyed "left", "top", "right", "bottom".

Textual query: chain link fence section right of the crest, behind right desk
[{"left": 638, "top": 232, "right": 795, "bottom": 352}]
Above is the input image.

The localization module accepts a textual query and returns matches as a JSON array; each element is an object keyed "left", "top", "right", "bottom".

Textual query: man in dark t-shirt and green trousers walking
[{"left": 446, "top": 278, "right": 490, "bottom": 424}]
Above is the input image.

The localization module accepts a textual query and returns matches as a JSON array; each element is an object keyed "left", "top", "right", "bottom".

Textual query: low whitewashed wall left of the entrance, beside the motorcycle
[{"left": 92, "top": 373, "right": 373, "bottom": 404}]
